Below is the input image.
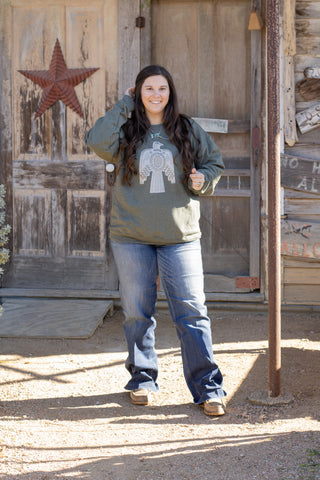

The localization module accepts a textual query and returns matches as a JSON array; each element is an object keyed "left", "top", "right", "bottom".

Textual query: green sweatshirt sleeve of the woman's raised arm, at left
[{"left": 85, "top": 95, "right": 134, "bottom": 163}]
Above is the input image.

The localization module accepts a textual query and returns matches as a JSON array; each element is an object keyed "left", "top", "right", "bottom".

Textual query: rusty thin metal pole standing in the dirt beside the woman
[{"left": 267, "top": 0, "right": 281, "bottom": 397}]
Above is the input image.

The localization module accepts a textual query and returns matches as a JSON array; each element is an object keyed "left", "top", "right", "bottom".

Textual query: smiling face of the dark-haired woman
[{"left": 141, "top": 75, "right": 170, "bottom": 125}]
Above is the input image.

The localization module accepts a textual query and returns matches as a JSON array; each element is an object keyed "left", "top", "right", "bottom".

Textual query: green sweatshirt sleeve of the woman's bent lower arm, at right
[{"left": 188, "top": 121, "right": 225, "bottom": 195}]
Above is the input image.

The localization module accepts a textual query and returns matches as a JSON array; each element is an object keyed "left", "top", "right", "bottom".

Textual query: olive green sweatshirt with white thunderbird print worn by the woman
[{"left": 86, "top": 95, "right": 224, "bottom": 245}]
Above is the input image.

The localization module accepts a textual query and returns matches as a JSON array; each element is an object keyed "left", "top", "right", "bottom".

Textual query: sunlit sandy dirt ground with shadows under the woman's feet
[{"left": 0, "top": 310, "right": 320, "bottom": 480}]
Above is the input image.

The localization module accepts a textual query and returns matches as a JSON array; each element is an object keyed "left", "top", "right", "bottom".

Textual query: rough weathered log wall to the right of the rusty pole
[{"left": 281, "top": 0, "right": 320, "bottom": 305}]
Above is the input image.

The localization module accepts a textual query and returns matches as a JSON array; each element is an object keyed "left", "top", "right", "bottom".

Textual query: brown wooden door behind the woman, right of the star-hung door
[{"left": 151, "top": 0, "right": 261, "bottom": 292}]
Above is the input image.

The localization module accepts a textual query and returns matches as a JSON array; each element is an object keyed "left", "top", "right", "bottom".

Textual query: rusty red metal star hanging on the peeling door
[{"left": 18, "top": 39, "right": 99, "bottom": 118}]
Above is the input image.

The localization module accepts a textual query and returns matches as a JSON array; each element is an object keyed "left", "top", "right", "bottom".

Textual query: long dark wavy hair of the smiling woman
[{"left": 120, "top": 65, "right": 199, "bottom": 185}]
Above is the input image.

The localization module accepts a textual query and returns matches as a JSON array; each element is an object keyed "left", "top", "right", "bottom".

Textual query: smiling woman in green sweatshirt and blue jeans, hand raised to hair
[{"left": 86, "top": 65, "right": 226, "bottom": 415}]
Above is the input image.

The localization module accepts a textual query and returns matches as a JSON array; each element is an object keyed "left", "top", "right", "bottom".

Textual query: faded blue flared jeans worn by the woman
[{"left": 111, "top": 240, "right": 226, "bottom": 403}]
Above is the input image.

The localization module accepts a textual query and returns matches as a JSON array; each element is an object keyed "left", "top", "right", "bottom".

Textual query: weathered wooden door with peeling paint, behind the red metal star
[{"left": 0, "top": 0, "right": 117, "bottom": 290}]
